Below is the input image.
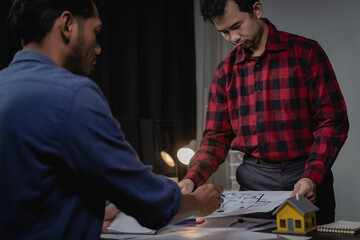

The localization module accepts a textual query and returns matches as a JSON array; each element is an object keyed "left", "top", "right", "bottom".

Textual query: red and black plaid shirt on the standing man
[{"left": 185, "top": 19, "right": 349, "bottom": 186}]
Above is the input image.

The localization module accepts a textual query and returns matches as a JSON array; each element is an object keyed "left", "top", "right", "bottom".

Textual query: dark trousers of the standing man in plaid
[{"left": 236, "top": 155, "right": 335, "bottom": 225}]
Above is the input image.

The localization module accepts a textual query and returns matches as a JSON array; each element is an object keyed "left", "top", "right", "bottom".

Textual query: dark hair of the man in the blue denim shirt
[{"left": 8, "top": 0, "right": 99, "bottom": 45}]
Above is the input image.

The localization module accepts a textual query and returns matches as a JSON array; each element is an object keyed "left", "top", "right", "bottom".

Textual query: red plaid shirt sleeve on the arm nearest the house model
[{"left": 303, "top": 43, "right": 349, "bottom": 184}]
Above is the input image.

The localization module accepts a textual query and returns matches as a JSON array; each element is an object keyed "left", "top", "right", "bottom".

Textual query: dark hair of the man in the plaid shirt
[{"left": 200, "top": 0, "right": 259, "bottom": 22}]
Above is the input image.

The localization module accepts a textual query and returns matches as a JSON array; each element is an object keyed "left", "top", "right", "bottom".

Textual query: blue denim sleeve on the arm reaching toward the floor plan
[{"left": 64, "top": 83, "right": 181, "bottom": 229}]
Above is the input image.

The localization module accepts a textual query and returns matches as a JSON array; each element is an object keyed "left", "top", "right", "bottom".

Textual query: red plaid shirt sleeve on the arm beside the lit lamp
[{"left": 185, "top": 62, "right": 235, "bottom": 186}]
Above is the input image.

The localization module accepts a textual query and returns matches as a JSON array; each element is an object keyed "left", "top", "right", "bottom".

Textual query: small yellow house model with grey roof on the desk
[{"left": 273, "top": 194, "right": 319, "bottom": 234}]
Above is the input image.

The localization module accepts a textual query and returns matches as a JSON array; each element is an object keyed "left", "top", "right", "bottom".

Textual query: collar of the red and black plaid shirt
[{"left": 235, "top": 18, "right": 286, "bottom": 64}]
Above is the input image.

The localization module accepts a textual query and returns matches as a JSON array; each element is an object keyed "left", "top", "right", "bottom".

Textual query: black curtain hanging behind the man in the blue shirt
[{"left": 0, "top": 0, "right": 196, "bottom": 165}]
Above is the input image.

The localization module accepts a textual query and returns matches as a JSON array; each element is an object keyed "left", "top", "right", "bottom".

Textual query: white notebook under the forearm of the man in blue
[{"left": 107, "top": 212, "right": 156, "bottom": 234}]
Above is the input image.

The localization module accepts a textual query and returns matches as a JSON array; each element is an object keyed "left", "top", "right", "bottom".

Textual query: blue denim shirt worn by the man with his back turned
[{"left": 0, "top": 51, "right": 181, "bottom": 239}]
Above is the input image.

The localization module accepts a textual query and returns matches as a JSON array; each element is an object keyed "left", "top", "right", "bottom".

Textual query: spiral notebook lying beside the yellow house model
[{"left": 317, "top": 220, "right": 360, "bottom": 234}]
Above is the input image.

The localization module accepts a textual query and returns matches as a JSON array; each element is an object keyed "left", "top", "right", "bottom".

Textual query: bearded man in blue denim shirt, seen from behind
[{"left": 0, "top": 0, "right": 223, "bottom": 239}]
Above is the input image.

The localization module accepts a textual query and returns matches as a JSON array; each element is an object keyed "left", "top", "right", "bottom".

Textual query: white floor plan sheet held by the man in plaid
[{"left": 206, "top": 191, "right": 291, "bottom": 218}]
